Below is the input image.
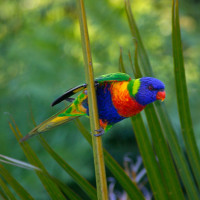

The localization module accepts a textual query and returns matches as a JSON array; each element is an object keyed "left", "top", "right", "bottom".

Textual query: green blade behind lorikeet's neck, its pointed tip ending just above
[{"left": 135, "top": 38, "right": 184, "bottom": 199}]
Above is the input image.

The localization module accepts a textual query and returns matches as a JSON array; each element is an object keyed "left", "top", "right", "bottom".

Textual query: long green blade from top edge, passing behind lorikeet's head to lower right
[{"left": 126, "top": 1, "right": 198, "bottom": 200}]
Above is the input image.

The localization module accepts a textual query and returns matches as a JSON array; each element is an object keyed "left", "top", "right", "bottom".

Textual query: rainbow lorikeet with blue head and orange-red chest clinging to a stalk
[{"left": 22, "top": 73, "right": 165, "bottom": 141}]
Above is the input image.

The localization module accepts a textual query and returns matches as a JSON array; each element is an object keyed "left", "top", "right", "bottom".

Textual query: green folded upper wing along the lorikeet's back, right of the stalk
[{"left": 95, "top": 72, "right": 131, "bottom": 83}]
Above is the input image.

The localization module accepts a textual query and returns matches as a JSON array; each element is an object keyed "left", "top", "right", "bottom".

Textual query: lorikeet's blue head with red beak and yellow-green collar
[{"left": 129, "top": 77, "right": 165, "bottom": 106}]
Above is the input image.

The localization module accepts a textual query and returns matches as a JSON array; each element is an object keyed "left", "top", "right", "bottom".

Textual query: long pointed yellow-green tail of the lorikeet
[{"left": 20, "top": 104, "right": 86, "bottom": 142}]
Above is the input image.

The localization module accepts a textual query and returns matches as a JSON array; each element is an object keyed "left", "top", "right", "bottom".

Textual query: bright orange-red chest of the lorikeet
[{"left": 110, "top": 81, "right": 145, "bottom": 117}]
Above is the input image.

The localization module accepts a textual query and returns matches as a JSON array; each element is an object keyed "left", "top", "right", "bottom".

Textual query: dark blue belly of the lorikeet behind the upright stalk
[{"left": 82, "top": 84, "right": 125, "bottom": 124}]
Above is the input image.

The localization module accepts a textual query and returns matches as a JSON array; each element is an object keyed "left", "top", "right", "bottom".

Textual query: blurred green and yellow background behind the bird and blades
[{"left": 0, "top": 0, "right": 200, "bottom": 199}]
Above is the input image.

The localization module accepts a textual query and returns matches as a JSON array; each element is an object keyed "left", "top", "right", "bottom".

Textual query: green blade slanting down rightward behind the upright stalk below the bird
[{"left": 76, "top": 119, "right": 144, "bottom": 200}]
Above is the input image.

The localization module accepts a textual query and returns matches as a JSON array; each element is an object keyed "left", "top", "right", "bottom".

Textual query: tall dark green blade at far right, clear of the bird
[{"left": 172, "top": 0, "right": 200, "bottom": 188}]
